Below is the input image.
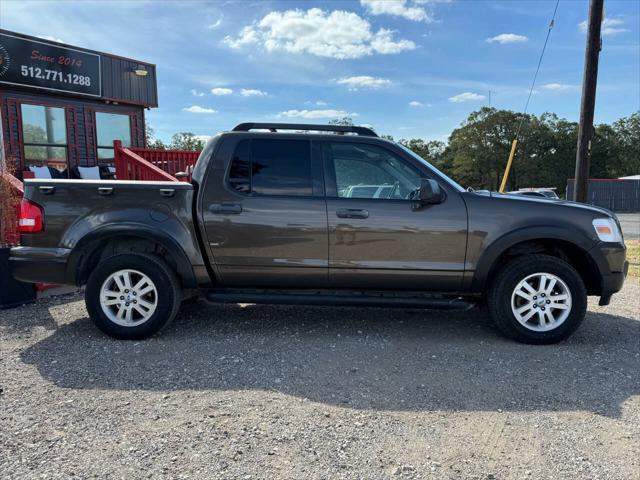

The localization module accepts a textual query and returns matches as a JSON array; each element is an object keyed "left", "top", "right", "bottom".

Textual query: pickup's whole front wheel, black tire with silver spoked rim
[{"left": 487, "top": 255, "right": 587, "bottom": 344}]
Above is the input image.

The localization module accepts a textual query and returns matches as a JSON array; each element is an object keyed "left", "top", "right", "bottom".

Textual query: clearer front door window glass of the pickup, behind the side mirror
[{"left": 329, "top": 142, "right": 420, "bottom": 200}]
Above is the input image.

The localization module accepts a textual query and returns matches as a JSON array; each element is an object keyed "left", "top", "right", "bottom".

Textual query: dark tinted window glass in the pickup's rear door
[{"left": 228, "top": 139, "right": 313, "bottom": 196}]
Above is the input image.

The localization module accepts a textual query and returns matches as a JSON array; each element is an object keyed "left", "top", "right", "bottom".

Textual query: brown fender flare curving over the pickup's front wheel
[{"left": 471, "top": 225, "right": 601, "bottom": 293}]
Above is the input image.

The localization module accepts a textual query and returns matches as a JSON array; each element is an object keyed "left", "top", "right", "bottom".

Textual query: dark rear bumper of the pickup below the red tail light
[{"left": 9, "top": 247, "right": 74, "bottom": 285}]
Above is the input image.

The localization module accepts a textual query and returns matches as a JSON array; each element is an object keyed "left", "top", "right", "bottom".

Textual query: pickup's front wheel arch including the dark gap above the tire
[{"left": 471, "top": 227, "right": 602, "bottom": 295}]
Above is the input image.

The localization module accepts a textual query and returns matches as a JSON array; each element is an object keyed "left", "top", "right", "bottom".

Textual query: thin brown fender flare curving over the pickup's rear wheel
[{"left": 67, "top": 223, "right": 197, "bottom": 288}]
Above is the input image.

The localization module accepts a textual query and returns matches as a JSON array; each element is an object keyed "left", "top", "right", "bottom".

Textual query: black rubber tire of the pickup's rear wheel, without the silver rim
[{"left": 85, "top": 253, "right": 182, "bottom": 340}]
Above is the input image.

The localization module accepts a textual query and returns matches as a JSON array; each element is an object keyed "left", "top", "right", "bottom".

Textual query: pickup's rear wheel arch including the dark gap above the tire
[{"left": 67, "top": 225, "right": 197, "bottom": 288}]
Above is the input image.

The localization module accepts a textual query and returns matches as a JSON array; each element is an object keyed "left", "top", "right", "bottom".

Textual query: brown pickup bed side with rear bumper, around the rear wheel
[{"left": 12, "top": 179, "right": 204, "bottom": 284}]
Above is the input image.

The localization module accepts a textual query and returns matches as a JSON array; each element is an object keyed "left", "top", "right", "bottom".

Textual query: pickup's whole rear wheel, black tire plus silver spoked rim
[{"left": 85, "top": 253, "right": 181, "bottom": 340}]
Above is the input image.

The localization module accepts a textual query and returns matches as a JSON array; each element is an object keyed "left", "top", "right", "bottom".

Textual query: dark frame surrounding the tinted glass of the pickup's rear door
[{"left": 223, "top": 136, "right": 325, "bottom": 199}]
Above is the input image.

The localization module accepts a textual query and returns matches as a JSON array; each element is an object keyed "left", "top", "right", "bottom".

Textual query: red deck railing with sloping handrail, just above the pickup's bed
[{"left": 113, "top": 140, "right": 200, "bottom": 182}]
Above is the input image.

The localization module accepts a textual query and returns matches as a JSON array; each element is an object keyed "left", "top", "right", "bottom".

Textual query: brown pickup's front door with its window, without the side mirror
[{"left": 323, "top": 141, "right": 467, "bottom": 291}]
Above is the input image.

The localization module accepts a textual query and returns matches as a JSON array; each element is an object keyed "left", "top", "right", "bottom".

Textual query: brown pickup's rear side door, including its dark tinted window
[{"left": 200, "top": 134, "right": 328, "bottom": 287}]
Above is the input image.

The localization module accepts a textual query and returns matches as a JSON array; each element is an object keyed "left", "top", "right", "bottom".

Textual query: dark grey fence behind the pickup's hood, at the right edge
[{"left": 567, "top": 178, "right": 640, "bottom": 212}]
